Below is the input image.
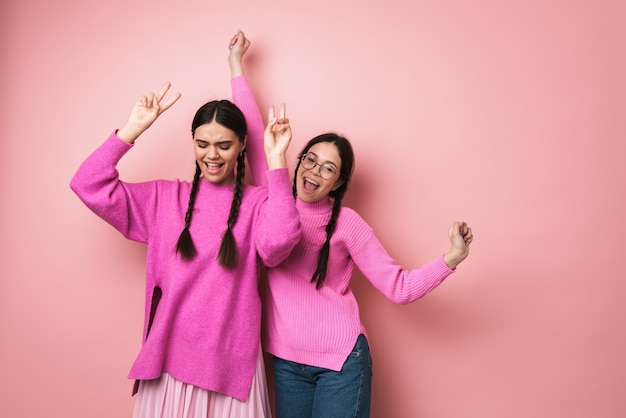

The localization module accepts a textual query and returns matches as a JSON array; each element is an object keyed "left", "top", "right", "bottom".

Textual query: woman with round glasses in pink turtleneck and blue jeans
[{"left": 231, "top": 31, "right": 473, "bottom": 418}]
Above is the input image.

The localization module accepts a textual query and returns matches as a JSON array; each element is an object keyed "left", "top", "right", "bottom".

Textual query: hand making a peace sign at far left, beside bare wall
[{"left": 117, "top": 82, "right": 181, "bottom": 144}]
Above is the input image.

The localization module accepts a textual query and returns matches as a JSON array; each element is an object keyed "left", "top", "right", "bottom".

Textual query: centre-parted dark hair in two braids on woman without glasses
[{"left": 176, "top": 100, "right": 248, "bottom": 267}]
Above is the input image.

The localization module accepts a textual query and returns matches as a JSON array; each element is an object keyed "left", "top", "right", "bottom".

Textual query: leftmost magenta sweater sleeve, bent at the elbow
[{"left": 70, "top": 133, "right": 156, "bottom": 242}]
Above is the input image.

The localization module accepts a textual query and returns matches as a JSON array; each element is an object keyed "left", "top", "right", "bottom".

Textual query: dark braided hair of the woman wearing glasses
[{"left": 293, "top": 132, "right": 354, "bottom": 289}]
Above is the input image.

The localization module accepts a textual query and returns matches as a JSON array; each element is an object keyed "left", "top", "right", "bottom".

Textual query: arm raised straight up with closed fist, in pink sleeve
[{"left": 228, "top": 30, "right": 267, "bottom": 186}]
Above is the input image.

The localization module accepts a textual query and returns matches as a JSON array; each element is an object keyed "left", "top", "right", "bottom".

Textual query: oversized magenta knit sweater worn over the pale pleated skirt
[{"left": 71, "top": 134, "right": 300, "bottom": 400}]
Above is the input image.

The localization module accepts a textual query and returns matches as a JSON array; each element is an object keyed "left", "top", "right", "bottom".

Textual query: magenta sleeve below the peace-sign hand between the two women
[{"left": 255, "top": 168, "right": 301, "bottom": 267}]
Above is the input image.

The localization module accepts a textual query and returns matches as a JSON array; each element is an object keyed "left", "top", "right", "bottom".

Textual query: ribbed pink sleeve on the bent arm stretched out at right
[{"left": 342, "top": 212, "right": 453, "bottom": 304}]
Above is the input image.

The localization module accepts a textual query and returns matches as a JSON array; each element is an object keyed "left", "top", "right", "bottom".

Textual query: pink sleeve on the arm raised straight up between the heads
[{"left": 230, "top": 75, "right": 267, "bottom": 187}]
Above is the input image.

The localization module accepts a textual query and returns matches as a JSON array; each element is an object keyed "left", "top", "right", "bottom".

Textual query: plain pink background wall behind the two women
[{"left": 0, "top": 0, "right": 626, "bottom": 418}]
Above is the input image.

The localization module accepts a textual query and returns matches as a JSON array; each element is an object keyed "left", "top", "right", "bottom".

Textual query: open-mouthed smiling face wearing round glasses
[{"left": 296, "top": 142, "right": 343, "bottom": 203}]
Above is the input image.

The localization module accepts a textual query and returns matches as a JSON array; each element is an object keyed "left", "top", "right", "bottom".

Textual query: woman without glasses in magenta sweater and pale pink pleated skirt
[{"left": 71, "top": 72, "right": 300, "bottom": 418}]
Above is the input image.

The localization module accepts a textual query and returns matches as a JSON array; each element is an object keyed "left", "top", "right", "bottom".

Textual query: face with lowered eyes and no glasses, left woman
[{"left": 193, "top": 121, "right": 245, "bottom": 184}]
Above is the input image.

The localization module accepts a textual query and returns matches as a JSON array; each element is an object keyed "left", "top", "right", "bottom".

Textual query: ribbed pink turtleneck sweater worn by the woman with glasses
[{"left": 233, "top": 77, "right": 452, "bottom": 370}]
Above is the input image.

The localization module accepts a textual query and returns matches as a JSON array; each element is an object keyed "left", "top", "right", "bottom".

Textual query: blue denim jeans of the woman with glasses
[{"left": 274, "top": 334, "right": 372, "bottom": 418}]
